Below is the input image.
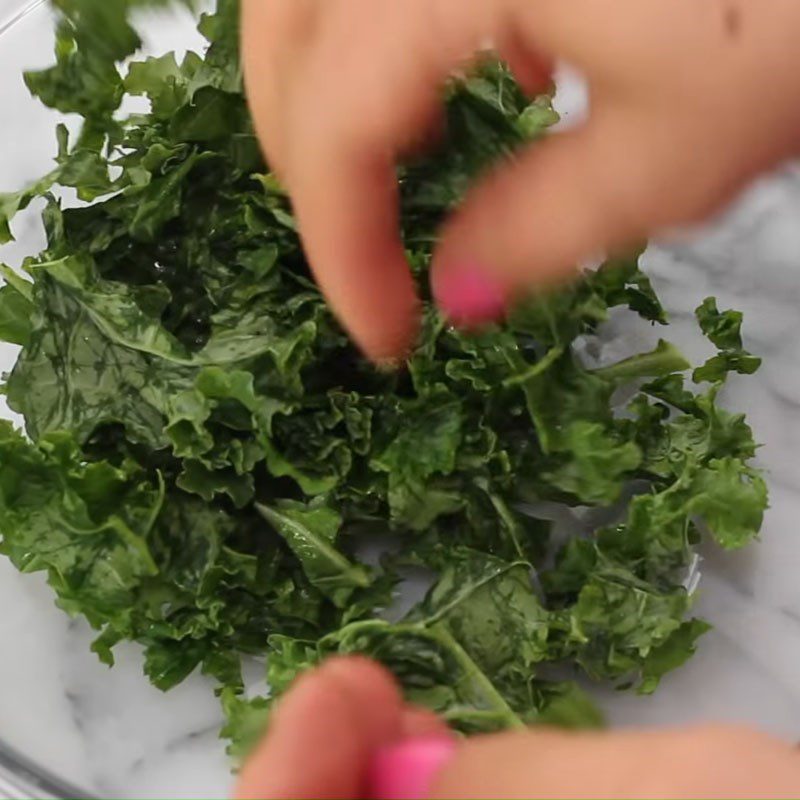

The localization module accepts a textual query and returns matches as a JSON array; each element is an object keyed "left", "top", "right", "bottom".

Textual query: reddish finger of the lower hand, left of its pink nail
[{"left": 235, "top": 658, "right": 402, "bottom": 800}]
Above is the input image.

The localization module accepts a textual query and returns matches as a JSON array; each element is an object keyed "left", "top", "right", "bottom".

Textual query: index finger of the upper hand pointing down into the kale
[{"left": 278, "top": 0, "right": 506, "bottom": 362}]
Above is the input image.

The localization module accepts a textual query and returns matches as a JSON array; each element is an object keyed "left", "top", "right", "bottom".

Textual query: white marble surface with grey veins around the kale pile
[{"left": 0, "top": 0, "right": 800, "bottom": 797}]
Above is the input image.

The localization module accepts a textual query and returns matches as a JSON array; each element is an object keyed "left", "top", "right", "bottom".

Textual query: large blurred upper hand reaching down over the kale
[{"left": 243, "top": 0, "right": 800, "bottom": 361}]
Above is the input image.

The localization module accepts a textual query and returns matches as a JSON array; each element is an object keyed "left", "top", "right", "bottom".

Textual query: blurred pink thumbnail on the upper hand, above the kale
[{"left": 432, "top": 262, "right": 508, "bottom": 327}]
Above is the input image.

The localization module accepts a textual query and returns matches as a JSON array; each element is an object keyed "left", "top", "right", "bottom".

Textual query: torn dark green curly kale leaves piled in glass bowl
[{"left": 0, "top": 0, "right": 767, "bottom": 756}]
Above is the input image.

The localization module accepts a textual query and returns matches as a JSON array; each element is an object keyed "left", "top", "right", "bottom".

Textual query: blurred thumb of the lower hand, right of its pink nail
[{"left": 430, "top": 725, "right": 800, "bottom": 798}]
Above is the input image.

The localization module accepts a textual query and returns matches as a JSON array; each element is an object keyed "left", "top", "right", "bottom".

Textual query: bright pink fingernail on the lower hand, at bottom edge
[{"left": 368, "top": 737, "right": 456, "bottom": 800}]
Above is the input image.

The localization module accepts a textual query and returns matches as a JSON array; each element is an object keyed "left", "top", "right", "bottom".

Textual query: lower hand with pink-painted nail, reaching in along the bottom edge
[{"left": 236, "top": 659, "right": 800, "bottom": 800}]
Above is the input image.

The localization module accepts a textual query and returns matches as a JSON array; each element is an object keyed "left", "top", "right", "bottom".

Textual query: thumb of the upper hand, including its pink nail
[{"left": 432, "top": 112, "right": 695, "bottom": 324}]
